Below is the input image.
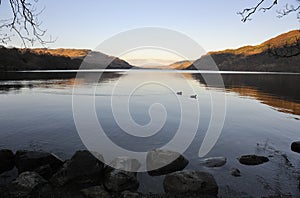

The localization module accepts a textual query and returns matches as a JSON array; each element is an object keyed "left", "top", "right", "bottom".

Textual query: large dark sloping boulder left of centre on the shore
[{"left": 50, "top": 150, "right": 104, "bottom": 186}]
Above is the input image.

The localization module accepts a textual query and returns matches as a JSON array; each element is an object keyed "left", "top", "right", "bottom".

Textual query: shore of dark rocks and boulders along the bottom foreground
[{"left": 0, "top": 146, "right": 300, "bottom": 198}]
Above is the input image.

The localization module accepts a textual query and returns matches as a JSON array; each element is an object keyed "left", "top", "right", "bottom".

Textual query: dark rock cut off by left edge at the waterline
[{"left": 0, "top": 149, "right": 15, "bottom": 174}]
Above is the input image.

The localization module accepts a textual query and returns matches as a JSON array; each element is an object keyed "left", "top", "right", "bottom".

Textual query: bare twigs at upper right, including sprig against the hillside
[{"left": 238, "top": 0, "right": 300, "bottom": 58}]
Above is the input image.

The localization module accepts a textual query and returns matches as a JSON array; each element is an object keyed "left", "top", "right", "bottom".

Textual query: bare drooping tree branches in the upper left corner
[{"left": 0, "top": 0, "right": 54, "bottom": 47}]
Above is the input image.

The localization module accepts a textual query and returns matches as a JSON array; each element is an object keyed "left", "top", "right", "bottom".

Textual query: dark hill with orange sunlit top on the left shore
[{"left": 0, "top": 46, "right": 133, "bottom": 71}]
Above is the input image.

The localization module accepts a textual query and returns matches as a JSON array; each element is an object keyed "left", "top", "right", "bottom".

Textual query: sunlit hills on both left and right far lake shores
[{"left": 0, "top": 30, "right": 300, "bottom": 72}]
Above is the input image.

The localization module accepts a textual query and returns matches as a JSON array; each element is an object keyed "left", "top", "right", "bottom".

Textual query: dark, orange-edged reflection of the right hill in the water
[{"left": 192, "top": 74, "right": 300, "bottom": 115}]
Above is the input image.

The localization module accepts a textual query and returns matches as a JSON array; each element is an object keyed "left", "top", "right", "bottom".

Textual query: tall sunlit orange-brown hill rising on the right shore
[{"left": 186, "top": 30, "right": 300, "bottom": 72}]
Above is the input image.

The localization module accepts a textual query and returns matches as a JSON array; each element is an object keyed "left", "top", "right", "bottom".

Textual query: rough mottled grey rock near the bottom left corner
[{"left": 8, "top": 172, "right": 47, "bottom": 198}]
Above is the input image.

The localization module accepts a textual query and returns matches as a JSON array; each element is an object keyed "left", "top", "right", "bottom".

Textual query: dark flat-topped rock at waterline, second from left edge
[{"left": 16, "top": 150, "right": 63, "bottom": 173}]
